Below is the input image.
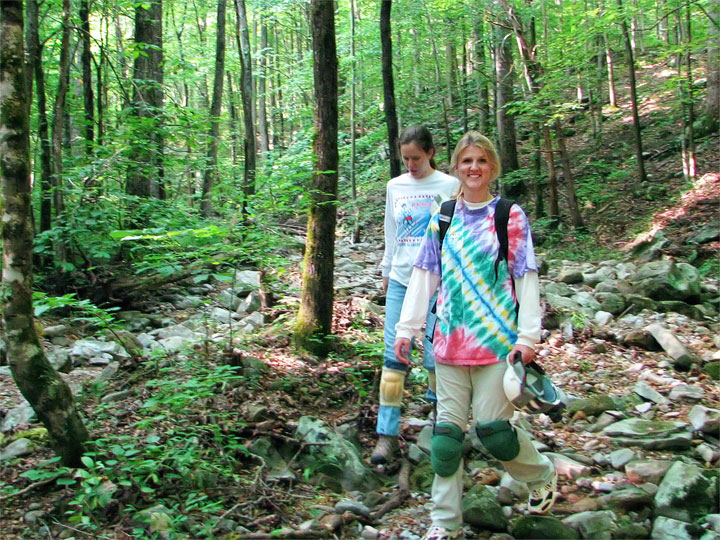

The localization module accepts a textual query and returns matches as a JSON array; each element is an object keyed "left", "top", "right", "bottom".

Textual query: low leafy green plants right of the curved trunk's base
[{"left": 9, "top": 359, "right": 251, "bottom": 538}]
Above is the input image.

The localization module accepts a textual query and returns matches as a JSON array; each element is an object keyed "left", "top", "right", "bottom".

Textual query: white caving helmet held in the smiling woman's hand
[{"left": 503, "top": 354, "right": 567, "bottom": 420}]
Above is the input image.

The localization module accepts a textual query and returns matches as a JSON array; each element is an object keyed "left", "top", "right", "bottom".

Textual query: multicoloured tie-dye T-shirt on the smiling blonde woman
[{"left": 415, "top": 197, "right": 537, "bottom": 365}]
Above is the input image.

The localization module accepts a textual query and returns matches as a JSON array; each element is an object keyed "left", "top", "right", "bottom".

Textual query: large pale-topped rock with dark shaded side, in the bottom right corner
[{"left": 655, "top": 461, "right": 718, "bottom": 523}]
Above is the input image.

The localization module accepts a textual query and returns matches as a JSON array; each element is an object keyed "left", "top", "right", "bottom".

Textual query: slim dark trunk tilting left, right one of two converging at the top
[{"left": 235, "top": 0, "right": 257, "bottom": 219}]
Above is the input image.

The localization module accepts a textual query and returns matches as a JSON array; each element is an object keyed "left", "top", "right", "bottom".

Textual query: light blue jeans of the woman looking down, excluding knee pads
[{"left": 376, "top": 279, "right": 437, "bottom": 437}]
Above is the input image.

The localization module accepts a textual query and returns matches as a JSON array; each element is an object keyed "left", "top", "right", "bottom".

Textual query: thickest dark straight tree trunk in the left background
[{"left": 125, "top": 0, "right": 165, "bottom": 200}]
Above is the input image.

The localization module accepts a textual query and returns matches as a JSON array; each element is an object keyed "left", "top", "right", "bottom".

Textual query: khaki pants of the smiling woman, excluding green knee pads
[{"left": 430, "top": 362, "right": 555, "bottom": 530}]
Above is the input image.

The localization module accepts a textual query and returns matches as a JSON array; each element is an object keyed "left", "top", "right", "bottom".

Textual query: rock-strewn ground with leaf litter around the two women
[{"left": 0, "top": 178, "right": 720, "bottom": 540}]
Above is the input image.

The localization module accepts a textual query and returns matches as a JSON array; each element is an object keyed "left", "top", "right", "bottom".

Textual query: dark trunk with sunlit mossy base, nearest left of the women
[{"left": 294, "top": 0, "right": 338, "bottom": 355}]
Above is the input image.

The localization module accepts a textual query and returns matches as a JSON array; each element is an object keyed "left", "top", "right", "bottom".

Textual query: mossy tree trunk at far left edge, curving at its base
[{"left": 0, "top": 0, "right": 88, "bottom": 467}]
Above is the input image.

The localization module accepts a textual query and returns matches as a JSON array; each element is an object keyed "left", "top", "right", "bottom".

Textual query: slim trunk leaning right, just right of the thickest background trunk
[{"left": 200, "top": 0, "right": 227, "bottom": 217}]
